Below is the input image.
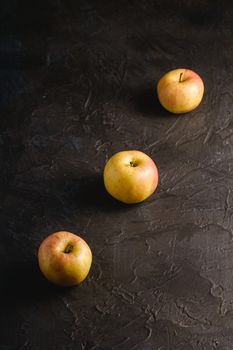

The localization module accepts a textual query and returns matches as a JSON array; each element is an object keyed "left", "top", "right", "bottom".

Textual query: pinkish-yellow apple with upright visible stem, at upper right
[{"left": 157, "top": 69, "right": 204, "bottom": 113}]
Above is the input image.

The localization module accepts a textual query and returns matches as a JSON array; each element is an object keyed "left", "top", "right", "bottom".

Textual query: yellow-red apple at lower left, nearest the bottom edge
[{"left": 38, "top": 231, "right": 92, "bottom": 287}]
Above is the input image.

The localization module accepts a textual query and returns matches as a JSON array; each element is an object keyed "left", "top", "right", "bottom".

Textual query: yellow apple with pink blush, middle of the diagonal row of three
[{"left": 104, "top": 150, "right": 158, "bottom": 204}]
